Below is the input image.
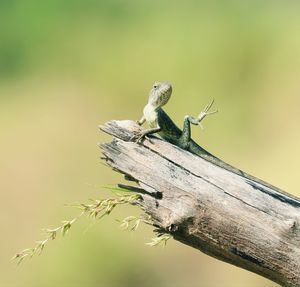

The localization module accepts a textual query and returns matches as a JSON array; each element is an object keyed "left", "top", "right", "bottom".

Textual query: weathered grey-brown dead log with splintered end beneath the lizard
[{"left": 100, "top": 121, "right": 300, "bottom": 287}]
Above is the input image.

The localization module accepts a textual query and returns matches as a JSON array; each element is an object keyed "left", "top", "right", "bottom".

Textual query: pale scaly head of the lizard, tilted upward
[{"left": 148, "top": 82, "right": 172, "bottom": 109}]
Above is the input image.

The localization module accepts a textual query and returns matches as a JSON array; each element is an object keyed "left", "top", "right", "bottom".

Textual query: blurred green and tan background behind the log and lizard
[{"left": 0, "top": 0, "right": 300, "bottom": 287}]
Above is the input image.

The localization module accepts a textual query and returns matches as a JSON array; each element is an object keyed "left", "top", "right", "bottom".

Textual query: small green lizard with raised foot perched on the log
[{"left": 130, "top": 81, "right": 300, "bottom": 200}]
